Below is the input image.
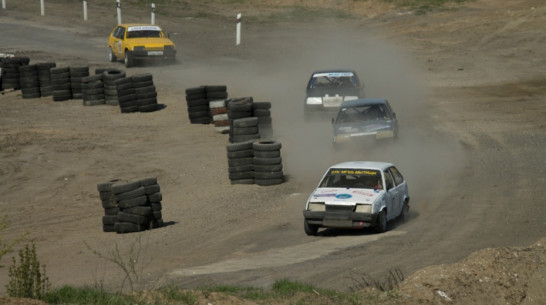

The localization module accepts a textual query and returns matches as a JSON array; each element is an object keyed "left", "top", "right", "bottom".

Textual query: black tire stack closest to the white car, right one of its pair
[{"left": 252, "top": 140, "right": 284, "bottom": 186}]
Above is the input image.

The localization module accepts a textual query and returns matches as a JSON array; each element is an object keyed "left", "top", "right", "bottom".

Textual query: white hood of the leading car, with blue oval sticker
[{"left": 309, "top": 188, "right": 385, "bottom": 205}]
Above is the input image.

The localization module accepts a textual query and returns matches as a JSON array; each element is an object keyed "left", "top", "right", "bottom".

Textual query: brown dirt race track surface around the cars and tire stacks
[{"left": 0, "top": 0, "right": 546, "bottom": 300}]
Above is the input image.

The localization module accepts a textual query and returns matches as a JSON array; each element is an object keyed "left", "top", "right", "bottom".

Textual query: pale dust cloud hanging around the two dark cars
[{"left": 164, "top": 21, "right": 462, "bottom": 209}]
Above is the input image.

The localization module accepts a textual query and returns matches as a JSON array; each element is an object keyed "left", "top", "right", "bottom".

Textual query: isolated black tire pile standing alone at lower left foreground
[{"left": 97, "top": 178, "right": 164, "bottom": 233}]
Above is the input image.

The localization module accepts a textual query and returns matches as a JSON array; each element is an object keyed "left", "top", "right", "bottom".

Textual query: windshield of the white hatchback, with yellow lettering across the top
[{"left": 319, "top": 168, "right": 383, "bottom": 190}]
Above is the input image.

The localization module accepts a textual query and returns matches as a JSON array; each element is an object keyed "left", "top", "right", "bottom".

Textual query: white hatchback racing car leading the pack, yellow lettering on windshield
[{"left": 303, "top": 161, "right": 409, "bottom": 235}]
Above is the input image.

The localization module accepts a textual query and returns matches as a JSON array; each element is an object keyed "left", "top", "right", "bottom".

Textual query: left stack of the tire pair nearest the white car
[{"left": 226, "top": 140, "right": 254, "bottom": 184}]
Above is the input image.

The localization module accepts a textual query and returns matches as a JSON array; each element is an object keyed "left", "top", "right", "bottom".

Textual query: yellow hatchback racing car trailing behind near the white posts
[{"left": 108, "top": 23, "right": 176, "bottom": 68}]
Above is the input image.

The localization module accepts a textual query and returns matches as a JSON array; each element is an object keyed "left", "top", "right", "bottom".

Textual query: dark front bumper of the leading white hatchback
[{"left": 303, "top": 210, "right": 378, "bottom": 228}]
